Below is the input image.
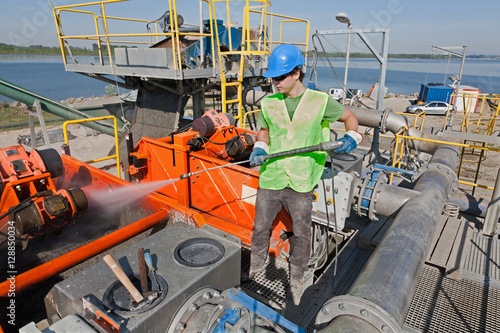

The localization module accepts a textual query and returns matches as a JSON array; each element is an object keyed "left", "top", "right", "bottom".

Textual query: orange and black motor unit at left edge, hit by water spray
[{"left": 0, "top": 146, "right": 87, "bottom": 247}]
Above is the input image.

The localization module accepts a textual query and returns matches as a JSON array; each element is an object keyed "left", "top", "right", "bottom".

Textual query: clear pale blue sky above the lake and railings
[{"left": 0, "top": 0, "right": 500, "bottom": 55}]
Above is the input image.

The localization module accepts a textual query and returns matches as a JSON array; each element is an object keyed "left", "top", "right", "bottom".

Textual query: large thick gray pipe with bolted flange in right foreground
[{"left": 321, "top": 146, "right": 459, "bottom": 332}]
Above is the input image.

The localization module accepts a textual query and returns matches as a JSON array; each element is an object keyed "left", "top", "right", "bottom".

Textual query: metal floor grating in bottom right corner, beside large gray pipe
[{"left": 404, "top": 265, "right": 500, "bottom": 333}]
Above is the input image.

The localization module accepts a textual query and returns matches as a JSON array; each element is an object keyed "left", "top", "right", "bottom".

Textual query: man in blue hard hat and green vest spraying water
[{"left": 249, "top": 44, "right": 363, "bottom": 304}]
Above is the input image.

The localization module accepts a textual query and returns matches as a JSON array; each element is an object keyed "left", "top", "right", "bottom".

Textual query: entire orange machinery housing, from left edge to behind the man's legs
[{"left": 0, "top": 117, "right": 292, "bottom": 296}]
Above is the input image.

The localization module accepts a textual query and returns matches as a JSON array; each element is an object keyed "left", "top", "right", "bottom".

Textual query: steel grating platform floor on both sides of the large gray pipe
[{"left": 241, "top": 211, "right": 500, "bottom": 333}]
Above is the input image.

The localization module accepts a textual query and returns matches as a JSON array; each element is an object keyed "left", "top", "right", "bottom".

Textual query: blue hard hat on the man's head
[{"left": 264, "top": 44, "right": 306, "bottom": 77}]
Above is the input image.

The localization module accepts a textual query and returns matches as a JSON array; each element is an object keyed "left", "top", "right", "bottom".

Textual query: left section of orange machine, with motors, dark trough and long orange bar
[{"left": 0, "top": 146, "right": 204, "bottom": 297}]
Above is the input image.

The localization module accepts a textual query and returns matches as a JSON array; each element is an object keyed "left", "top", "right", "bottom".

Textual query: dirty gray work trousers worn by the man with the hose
[{"left": 250, "top": 188, "right": 313, "bottom": 280}]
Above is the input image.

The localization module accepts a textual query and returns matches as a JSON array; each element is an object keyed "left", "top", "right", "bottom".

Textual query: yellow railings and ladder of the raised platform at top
[{"left": 53, "top": 0, "right": 310, "bottom": 126}]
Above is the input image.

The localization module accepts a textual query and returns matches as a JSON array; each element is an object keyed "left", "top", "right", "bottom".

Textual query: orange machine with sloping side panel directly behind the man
[{"left": 128, "top": 111, "right": 292, "bottom": 256}]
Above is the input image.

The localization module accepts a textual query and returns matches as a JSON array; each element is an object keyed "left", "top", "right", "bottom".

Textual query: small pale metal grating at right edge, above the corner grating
[{"left": 462, "top": 231, "right": 500, "bottom": 288}]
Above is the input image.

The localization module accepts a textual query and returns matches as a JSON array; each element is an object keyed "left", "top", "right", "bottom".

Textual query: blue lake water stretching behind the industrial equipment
[{"left": 0, "top": 55, "right": 500, "bottom": 102}]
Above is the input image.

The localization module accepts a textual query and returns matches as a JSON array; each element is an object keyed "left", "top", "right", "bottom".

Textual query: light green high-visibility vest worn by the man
[{"left": 259, "top": 89, "right": 330, "bottom": 193}]
